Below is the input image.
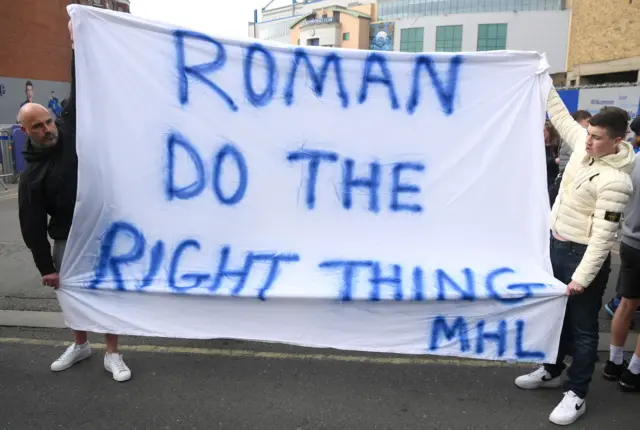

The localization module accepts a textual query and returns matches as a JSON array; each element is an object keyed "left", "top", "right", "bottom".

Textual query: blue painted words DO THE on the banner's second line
[{"left": 164, "top": 132, "right": 425, "bottom": 213}]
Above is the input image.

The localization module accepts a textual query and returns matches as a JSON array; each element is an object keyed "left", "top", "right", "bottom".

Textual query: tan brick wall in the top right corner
[{"left": 567, "top": 0, "right": 640, "bottom": 70}]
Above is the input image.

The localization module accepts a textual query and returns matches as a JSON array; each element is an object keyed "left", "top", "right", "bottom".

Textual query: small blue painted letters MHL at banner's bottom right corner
[{"left": 429, "top": 315, "right": 545, "bottom": 360}]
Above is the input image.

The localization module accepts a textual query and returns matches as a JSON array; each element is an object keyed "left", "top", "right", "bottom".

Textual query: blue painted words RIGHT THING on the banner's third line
[{"left": 89, "top": 222, "right": 546, "bottom": 304}]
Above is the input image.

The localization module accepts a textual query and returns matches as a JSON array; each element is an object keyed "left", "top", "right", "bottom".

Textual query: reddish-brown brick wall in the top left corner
[{"left": 0, "top": 0, "right": 72, "bottom": 82}]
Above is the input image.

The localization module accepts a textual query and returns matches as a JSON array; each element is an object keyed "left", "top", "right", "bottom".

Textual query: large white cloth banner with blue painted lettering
[{"left": 59, "top": 6, "right": 566, "bottom": 362}]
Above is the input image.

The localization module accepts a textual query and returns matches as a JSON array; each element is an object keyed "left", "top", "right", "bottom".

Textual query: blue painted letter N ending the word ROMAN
[{"left": 407, "top": 55, "right": 463, "bottom": 115}]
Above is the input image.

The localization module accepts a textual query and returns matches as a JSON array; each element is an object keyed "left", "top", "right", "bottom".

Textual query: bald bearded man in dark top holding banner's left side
[{"left": 18, "top": 21, "right": 131, "bottom": 382}]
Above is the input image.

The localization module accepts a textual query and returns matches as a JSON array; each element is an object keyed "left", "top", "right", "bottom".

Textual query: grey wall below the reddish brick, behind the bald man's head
[{"left": 0, "top": 76, "right": 70, "bottom": 124}]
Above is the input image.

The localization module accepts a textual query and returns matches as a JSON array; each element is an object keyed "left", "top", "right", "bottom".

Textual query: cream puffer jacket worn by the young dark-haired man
[{"left": 547, "top": 88, "right": 635, "bottom": 287}]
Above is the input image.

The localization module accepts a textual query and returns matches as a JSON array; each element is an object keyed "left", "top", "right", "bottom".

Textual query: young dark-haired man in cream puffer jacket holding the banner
[{"left": 516, "top": 88, "right": 635, "bottom": 425}]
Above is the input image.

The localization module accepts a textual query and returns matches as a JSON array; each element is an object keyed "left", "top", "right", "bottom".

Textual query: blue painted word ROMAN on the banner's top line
[{"left": 174, "top": 30, "right": 463, "bottom": 115}]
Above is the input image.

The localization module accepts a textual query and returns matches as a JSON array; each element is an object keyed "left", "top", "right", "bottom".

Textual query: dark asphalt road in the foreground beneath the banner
[{"left": 0, "top": 329, "right": 640, "bottom": 430}]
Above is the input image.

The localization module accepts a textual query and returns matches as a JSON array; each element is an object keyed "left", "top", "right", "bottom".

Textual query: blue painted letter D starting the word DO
[{"left": 164, "top": 133, "right": 205, "bottom": 200}]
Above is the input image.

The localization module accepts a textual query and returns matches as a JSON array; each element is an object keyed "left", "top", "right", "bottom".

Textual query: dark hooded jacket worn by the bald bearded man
[{"left": 18, "top": 53, "right": 78, "bottom": 276}]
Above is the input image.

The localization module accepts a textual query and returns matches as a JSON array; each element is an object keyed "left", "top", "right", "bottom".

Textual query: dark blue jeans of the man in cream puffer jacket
[{"left": 544, "top": 237, "right": 611, "bottom": 399}]
